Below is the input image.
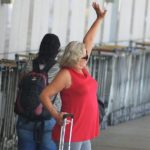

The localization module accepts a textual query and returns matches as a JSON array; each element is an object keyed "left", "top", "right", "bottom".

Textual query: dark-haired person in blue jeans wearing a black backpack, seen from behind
[{"left": 15, "top": 33, "right": 61, "bottom": 150}]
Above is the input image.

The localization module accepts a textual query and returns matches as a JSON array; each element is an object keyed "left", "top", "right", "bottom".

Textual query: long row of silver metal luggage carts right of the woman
[{"left": 89, "top": 42, "right": 150, "bottom": 126}]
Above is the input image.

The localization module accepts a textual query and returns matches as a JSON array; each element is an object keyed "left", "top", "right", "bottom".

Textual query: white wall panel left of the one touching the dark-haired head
[{"left": 9, "top": 0, "right": 29, "bottom": 56}]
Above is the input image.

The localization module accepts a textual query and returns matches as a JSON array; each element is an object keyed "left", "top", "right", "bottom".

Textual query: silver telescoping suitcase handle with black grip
[{"left": 59, "top": 114, "right": 74, "bottom": 150}]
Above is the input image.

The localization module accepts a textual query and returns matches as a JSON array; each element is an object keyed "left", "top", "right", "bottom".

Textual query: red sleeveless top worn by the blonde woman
[{"left": 52, "top": 68, "right": 99, "bottom": 142}]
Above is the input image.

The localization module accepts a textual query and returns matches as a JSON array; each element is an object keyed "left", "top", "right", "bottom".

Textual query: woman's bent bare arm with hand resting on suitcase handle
[{"left": 40, "top": 69, "right": 70, "bottom": 124}]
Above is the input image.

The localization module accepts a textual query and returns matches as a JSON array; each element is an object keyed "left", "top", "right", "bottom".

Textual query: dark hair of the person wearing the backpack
[{"left": 33, "top": 33, "right": 60, "bottom": 70}]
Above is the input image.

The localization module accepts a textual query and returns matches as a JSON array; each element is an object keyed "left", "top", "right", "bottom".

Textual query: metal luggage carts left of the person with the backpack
[{"left": 0, "top": 55, "right": 32, "bottom": 150}]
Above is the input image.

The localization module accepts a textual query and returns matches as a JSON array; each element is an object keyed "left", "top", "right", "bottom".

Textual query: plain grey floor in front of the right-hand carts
[{"left": 92, "top": 115, "right": 150, "bottom": 150}]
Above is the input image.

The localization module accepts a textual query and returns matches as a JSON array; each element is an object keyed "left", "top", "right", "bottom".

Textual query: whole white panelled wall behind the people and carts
[{"left": 0, "top": 0, "right": 150, "bottom": 57}]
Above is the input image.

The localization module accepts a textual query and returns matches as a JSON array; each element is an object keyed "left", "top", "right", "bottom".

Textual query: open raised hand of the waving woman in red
[{"left": 92, "top": 2, "right": 106, "bottom": 19}]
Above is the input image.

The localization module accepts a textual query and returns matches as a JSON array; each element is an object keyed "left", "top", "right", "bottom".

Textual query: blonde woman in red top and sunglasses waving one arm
[{"left": 40, "top": 2, "right": 106, "bottom": 150}]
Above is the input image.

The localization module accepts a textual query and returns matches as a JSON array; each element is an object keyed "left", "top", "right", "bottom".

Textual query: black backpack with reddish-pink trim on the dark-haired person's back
[{"left": 14, "top": 59, "right": 56, "bottom": 121}]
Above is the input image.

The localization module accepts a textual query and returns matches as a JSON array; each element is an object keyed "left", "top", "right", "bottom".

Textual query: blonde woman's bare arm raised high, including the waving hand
[{"left": 83, "top": 2, "right": 106, "bottom": 55}]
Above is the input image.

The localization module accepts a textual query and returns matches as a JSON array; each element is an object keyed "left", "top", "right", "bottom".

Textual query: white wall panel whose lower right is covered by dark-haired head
[{"left": 30, "top": 0, "right": 51, "bottom": 50}]
